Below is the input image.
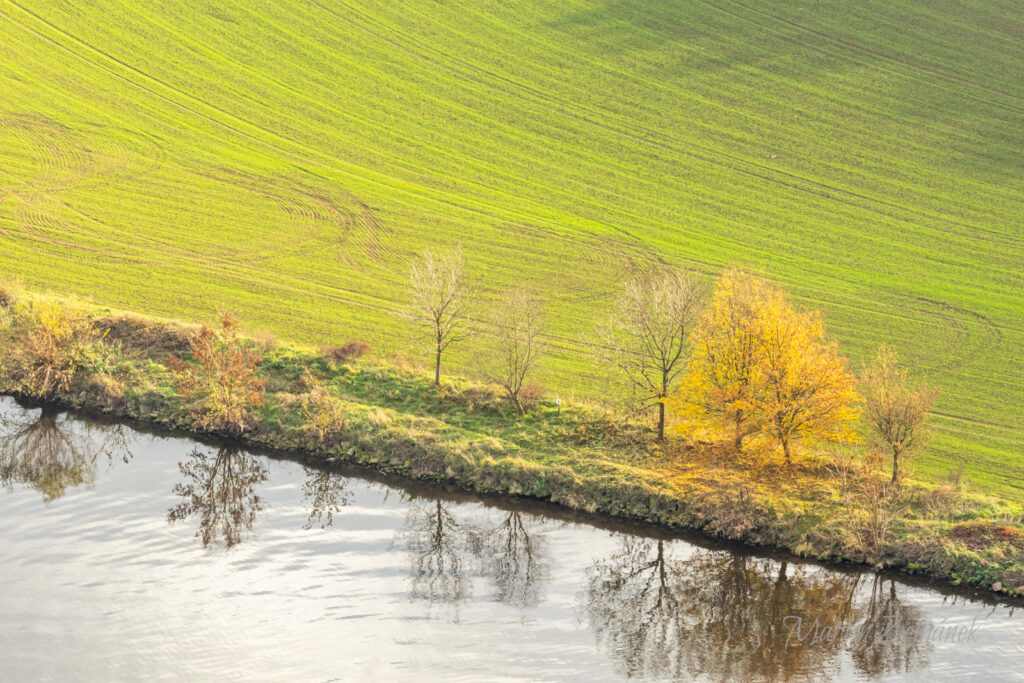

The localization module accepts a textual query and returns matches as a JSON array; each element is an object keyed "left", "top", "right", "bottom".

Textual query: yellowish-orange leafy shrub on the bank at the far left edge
[{"left": 0, "top": 297, "right": 98, "bottom": 397}]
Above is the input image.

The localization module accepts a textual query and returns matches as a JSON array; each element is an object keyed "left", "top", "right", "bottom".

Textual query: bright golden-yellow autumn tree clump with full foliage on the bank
[{"left": 673, "top": 268, "right": 857, "bottom": 462}]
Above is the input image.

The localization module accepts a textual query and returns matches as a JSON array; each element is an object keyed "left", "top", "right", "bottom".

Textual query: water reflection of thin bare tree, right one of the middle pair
[{"left": 480, "top": 511, "right": 547, "bottom": 607}]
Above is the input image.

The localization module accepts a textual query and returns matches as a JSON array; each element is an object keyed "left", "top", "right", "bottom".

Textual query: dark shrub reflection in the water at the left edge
[{"left": 0, "top": 407, "right": 131, "bottom": 503}]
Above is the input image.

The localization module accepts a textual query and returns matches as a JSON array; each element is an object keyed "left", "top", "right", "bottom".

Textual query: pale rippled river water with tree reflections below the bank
[{"left": 0, "top": 397, "right": 1024, "bottom": 681}]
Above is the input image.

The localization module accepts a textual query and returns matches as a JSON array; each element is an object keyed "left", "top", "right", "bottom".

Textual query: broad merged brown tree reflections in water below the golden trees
[{"left": 581, "top": 538, "right": 925, "bottom": 681}]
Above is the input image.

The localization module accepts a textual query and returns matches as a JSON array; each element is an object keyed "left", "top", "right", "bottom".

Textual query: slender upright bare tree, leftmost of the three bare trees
[{"left": 409, "top": 247, "right": 469, "bottom": 385}]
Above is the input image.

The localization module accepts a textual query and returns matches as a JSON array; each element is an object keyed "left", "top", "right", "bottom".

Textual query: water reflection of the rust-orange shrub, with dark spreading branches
[{"left": 167, "top": 449, "right": 267, "bottom": 548}]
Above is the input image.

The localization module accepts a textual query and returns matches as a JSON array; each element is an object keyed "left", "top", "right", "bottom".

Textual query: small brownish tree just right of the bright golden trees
[{"left": 860, "top": 345, "right": 939, "bottom": 483}]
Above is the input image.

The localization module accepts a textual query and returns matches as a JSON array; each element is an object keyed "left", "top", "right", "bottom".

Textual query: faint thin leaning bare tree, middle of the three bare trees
[{"left": 493, "top": 290, "right": 543, "bottom": 415}]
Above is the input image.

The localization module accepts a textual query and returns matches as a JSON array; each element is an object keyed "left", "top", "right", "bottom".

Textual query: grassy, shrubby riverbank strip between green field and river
[{"left": 0, "top": 294, "right": 1024, "bottom": 594}]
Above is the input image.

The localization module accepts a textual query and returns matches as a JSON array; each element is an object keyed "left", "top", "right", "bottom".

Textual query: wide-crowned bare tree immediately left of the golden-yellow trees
[{"left": 601, "top": 270, "right": 703, "bottom": 440}]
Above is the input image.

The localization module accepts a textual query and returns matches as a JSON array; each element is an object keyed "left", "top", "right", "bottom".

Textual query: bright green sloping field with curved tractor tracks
[{"left": 0, "top": 0, "right": 1024, "bottom": 500}]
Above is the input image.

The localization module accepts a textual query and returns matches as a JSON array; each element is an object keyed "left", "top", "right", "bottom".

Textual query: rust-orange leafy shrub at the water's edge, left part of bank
[{"left": 167, "top": 313, "right": 266, "bottom": 433}]
